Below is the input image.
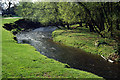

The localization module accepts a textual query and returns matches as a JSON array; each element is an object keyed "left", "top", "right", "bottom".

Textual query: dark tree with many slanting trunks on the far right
[{"left": 78, "top": 2, "right": 119, "bottom": 37}]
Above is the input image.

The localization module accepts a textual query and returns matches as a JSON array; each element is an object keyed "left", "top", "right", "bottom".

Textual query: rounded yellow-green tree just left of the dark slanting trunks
[{"left": 58, "top": 2, "right": 84, "bottom": 29}]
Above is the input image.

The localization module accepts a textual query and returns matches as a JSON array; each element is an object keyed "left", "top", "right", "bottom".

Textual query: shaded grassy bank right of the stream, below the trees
[{"left": 52, "top": 27, "right": 117, "bottom": 61}]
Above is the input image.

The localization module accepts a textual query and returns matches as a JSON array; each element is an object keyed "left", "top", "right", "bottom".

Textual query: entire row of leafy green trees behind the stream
[{"left": 16, "top": 2, "right": 120, "bottom": 37}]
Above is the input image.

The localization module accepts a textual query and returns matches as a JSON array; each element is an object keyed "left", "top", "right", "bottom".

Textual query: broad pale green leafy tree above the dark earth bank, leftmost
[{"left": 16, "top": 2, "right": 61, "bottom": 26}]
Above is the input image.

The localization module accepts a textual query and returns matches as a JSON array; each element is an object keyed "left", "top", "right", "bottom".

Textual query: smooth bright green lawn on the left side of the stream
[{"left": 2, "top": 19, "right": 101, "bottom": 78}]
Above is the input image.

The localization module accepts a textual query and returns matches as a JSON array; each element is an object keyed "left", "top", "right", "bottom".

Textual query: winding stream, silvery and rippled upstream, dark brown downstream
[{"left": 16, "top": 26, "right": 120, "bottom": 79}]
